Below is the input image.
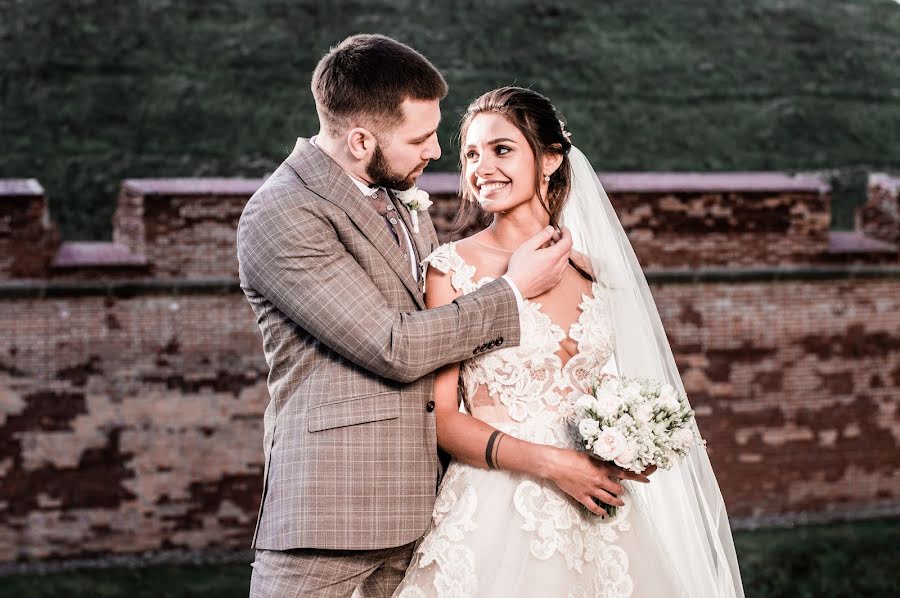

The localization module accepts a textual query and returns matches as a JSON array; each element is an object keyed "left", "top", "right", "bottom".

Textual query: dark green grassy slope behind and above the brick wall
[{"left": 0, "top": 0, "right": 900, "bottom": 239}]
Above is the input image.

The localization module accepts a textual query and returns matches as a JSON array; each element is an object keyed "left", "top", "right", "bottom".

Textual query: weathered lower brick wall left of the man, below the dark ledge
[{"left": 0, "top": 291, "right": 268, "bottom": 562}]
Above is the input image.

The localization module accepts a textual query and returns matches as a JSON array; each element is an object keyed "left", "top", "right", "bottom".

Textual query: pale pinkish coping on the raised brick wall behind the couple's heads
[{"left": 116, "top": 172, "right": 830, "bottom": 196}]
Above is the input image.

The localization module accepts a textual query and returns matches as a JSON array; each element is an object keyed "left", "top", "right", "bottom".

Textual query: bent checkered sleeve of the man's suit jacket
[{"left": 238, "top": 192, "right": 519, "bottom": 382}]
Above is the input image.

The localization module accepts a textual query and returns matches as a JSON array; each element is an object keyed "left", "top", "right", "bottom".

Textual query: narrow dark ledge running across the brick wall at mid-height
[{"left": 0, "top": 264, "right": 900, "bottom": 300}]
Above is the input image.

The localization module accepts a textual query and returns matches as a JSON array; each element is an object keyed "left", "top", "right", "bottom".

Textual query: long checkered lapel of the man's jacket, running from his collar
[{"left": 286, "top": 138, "right": 425, "bottom": 308}]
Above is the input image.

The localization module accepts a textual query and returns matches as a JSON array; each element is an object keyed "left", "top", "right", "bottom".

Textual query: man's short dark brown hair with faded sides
[{"left": 312, "top": 34, "right": 447, "bottom": 135}]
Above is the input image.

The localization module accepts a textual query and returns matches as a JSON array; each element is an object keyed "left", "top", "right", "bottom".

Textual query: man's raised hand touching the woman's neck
[{"left": 506, "top": 226, "right": 572, "bottom": 299}]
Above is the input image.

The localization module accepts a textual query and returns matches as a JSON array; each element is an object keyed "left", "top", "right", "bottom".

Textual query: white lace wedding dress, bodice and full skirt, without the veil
[{"left": 394, "top": 243, "right": 677, "bottom": 598}]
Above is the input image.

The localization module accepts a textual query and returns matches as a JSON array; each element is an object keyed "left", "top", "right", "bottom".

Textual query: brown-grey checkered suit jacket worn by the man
[{"left": 237, "top": 139, "right": 519, "bottom": 550}]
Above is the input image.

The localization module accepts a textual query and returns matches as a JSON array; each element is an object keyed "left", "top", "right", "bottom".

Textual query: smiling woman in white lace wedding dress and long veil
[{"left": 395, "top": 87, "right": 743, "bottom": 598}]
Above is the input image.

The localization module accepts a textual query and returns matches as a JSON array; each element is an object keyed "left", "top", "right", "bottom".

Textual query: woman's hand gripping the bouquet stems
[{"left": 546, "top": 447, "right": 656, "bottom": 516}]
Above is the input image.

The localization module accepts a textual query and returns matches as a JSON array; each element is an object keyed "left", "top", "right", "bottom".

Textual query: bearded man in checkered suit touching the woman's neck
[{"left": 237, "top": 35, "right": 571, "bottom": 598}]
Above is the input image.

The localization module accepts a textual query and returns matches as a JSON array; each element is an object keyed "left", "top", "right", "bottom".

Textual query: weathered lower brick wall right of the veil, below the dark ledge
[{"left": 654, "top": 278, "right": 900, "bottom": 517}]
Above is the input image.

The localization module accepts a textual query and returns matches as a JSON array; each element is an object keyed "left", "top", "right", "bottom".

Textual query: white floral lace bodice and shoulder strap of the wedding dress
[{"left": 423, "top": 243, "right": 615, "bottom": 446}]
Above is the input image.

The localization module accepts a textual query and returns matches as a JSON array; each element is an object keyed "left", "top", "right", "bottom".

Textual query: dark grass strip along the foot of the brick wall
[{"left": 0, "top": 519, "right": 900, "bottom": 598}]
